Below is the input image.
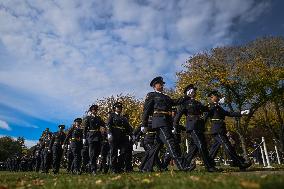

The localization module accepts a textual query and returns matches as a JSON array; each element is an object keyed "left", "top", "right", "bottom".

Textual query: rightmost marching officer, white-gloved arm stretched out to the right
[{"left": 208, "top": 91, "right": 251, "bottom": 170}]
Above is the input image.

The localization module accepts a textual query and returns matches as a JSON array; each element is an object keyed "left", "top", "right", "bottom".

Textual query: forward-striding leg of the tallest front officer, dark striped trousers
[{"left": 158, "top": 127, "right": 185, "bottom": 170}]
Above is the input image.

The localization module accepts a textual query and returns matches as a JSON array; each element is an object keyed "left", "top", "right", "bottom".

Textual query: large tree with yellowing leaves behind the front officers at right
[{"left": 177, "top": 37, "right": 284, "bottom": 157}]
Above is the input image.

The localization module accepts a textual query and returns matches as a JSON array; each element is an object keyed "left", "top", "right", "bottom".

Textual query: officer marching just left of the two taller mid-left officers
[{"left": 64, "top": 118, "right": 83, "bottom": 175}]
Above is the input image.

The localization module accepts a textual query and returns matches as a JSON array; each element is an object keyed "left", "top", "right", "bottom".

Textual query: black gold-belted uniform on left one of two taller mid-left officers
[{"left": 83, "top": 115, "right": 105, "bottom": 173}]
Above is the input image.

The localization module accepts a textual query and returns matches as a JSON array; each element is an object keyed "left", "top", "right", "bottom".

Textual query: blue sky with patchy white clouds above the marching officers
[{"left": 0, "top": 0, "right": 284, "bottom": 146}]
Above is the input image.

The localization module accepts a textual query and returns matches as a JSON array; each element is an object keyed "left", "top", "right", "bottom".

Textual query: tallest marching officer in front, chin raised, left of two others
[{"left": 142, "top": 77, "right": 191, "bottom": 170}]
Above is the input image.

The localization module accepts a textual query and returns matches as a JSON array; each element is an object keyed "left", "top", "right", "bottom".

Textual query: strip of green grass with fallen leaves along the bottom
[{"left": 0, "top": 167, "right": 284, "bottom": 189}]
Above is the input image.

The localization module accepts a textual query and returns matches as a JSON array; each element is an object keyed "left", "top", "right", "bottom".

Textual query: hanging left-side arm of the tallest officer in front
[{"left": 142, "top": 93, "right": 154, "bottom": 127}]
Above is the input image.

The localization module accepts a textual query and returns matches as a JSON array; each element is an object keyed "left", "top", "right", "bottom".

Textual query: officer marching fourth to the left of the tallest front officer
[{"left": 50, "top": 125, "right": 66, "bottom": 174}]
